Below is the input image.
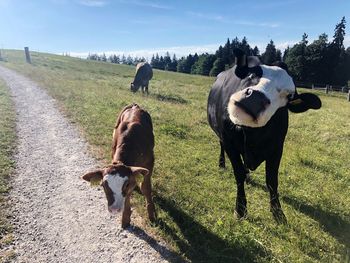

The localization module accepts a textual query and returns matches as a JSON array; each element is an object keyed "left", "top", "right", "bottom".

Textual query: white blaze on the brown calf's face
[{"left": 104, "top": 173, "right": 128, "bottom": 214}]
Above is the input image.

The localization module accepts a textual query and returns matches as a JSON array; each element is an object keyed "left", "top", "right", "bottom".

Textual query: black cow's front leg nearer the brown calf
[{"left": 224, "top": 148, "right": 247, "bottom": 219}]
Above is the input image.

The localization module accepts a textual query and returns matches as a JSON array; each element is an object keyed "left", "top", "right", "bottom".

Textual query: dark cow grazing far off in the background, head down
[{"left": 130, "top": 62, "right": 153, "bottom": 94}]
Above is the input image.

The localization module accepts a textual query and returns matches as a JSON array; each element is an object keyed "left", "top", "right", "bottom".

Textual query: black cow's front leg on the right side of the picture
[{"left": 265, "top": 150, "right": 287, "bottom": 223}]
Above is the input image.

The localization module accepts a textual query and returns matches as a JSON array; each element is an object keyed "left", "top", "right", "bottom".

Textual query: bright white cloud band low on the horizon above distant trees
[{"left": 68, "top": 44, "right": 220, "bottom": 60}]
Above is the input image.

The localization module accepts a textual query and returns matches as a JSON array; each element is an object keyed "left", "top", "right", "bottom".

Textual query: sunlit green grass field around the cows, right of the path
[{"left": 1, "top": 51, "right": 350, "bottom": 262}]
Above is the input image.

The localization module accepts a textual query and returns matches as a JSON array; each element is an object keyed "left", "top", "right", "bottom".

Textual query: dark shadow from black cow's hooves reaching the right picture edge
[{"left": 282, "top": 196, "right": 350, "bottom": 249}]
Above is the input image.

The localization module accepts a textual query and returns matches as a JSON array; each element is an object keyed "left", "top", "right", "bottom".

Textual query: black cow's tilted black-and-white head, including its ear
[{"left": 228, "top": 50, "right": 321, "bottom": 127}]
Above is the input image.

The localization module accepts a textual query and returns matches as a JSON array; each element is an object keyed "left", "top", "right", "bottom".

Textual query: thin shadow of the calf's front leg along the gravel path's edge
[{"left": 127, "top": 226, "right": 183, "bottom": 263}]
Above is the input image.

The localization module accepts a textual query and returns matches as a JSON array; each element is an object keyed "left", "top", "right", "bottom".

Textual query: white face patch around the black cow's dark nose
[{"left": 228, "top": 65, "right": 295, "bottom": 127}]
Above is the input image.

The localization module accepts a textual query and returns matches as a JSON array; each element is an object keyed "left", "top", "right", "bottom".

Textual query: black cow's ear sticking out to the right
[{"left": 287, "top": 93, "right": 322, "bottom": 113}]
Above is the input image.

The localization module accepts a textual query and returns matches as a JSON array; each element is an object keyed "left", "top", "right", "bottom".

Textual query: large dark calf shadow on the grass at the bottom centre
[{"left": 154, "top": 194, "right": 269, "bottom": 263}]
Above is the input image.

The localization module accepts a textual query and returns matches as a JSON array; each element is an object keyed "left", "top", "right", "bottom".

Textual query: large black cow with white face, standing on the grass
[{"left": 207, "top": 50, "right": 321, "bottom": 222}]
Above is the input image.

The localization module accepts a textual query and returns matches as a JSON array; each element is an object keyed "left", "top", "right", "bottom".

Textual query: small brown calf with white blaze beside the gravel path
[{"left": 82, "top": 104, "right": 156, "bottom": 228}]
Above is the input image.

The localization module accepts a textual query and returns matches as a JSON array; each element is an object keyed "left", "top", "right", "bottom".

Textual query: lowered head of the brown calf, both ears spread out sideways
[{"left": 82, "top": 164, "right": 149, "bottom": 213}]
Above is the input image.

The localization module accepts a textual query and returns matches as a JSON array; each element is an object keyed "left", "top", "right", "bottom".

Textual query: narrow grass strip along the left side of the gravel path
[{"left": 0, "top": 79, "right": 16, "bottom": 262}]
